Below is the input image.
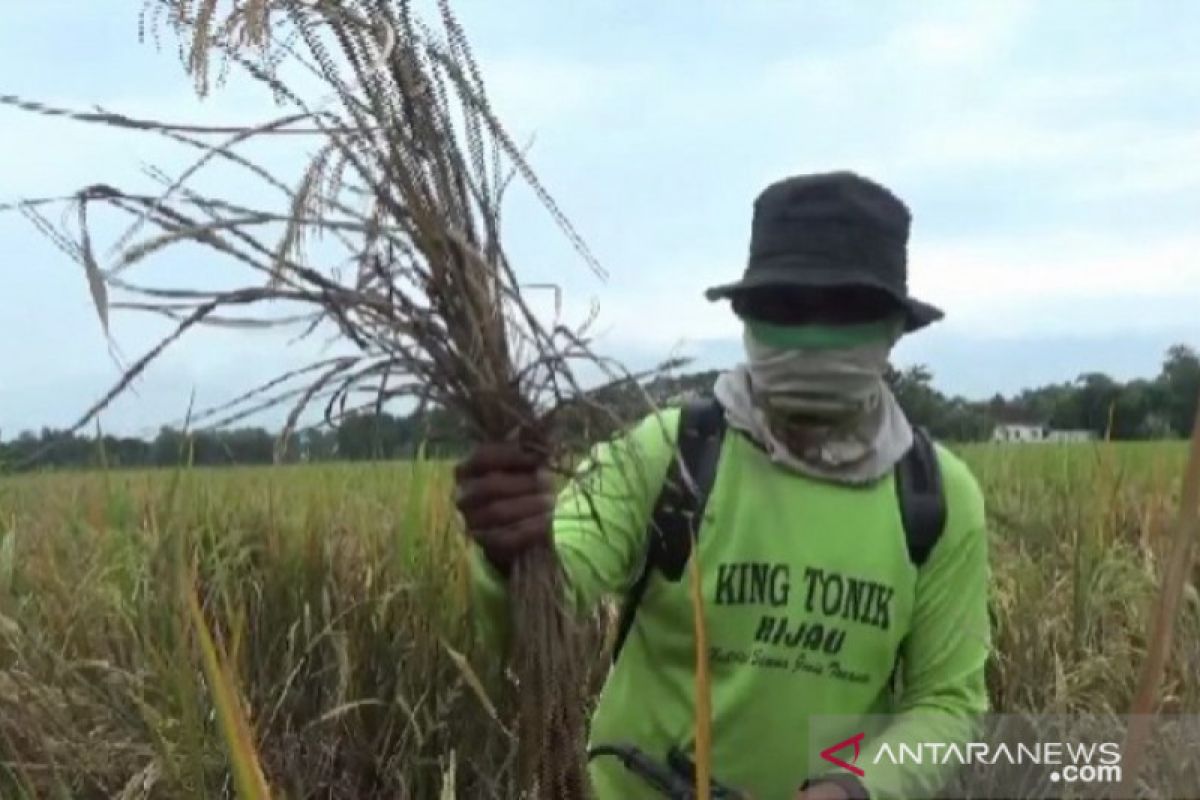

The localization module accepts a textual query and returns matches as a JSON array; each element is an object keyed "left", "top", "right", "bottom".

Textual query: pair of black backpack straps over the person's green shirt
[{"left": 612, "top": 397, "right": 947, "bottom": 662}]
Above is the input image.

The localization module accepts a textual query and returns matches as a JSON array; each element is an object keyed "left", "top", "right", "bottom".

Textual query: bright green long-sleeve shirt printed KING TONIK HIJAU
[{"left": 474, "top": 409, "right": 990, "bottom": 800}]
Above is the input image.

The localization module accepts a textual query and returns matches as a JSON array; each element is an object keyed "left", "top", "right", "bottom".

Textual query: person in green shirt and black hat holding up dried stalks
[{"left": 456, "top": 173, "right": 990, "bottom": 800}]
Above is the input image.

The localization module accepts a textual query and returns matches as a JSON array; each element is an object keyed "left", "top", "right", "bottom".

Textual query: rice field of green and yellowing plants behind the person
[{"left": 0, "top": 444, "right": 1200, "bottom": 799}]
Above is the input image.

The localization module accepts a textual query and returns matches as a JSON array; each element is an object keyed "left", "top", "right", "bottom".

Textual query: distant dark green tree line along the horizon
[{"left": 0, "top": 344, "right": 1200, "bottom": 469}]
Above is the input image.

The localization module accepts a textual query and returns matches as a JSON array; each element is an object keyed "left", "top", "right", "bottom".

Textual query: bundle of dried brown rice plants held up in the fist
[{"left": 0, "top": 0, "right": 686, "bottom": 799}]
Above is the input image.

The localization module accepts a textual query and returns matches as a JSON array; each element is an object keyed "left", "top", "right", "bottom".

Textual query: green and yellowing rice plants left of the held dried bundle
[{"left": 0, "top": 453, "right": 530, "bottom": 798}]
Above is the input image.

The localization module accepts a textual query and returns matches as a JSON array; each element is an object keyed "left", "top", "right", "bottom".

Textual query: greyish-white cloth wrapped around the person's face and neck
[{"left": 715, "top": 320, "right": 912, "bottom": 485}]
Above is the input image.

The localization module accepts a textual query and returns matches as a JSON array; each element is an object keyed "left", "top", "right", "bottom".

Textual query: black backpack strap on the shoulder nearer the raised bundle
[{"left": 612, "top": 397, "right": 725, "bottom": 661}]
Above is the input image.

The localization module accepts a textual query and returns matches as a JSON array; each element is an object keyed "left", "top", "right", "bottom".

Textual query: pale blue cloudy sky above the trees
[{"left": 0, "top": 0, "right": 1200, "bottom": 435}]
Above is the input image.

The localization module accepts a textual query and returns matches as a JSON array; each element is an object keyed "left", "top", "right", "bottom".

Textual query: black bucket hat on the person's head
[{"left": 704, "top": 172, "right": 944, "bottom": 332}]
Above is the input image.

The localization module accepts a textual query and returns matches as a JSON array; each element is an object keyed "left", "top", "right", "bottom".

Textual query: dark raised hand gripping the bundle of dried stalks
[{"left": 455, "top": 443, "right": 554, "bottom": 575}]
